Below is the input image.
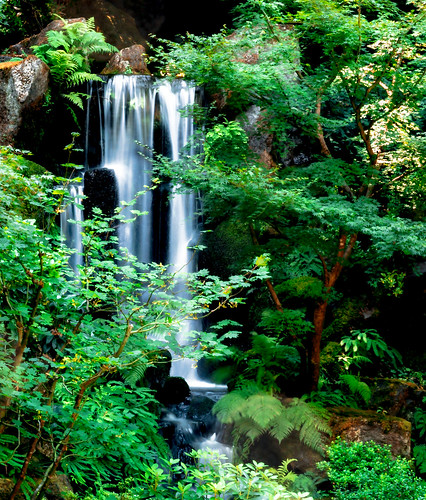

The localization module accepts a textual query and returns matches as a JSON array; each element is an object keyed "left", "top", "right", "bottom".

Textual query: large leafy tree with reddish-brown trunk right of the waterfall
[{"left": 149, "top": 0, "right": 426, "bottom": 390}]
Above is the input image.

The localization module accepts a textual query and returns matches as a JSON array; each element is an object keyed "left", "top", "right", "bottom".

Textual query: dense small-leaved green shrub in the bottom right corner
[{"left": 318, "top": 439, "right": 426, "bottom": 500}]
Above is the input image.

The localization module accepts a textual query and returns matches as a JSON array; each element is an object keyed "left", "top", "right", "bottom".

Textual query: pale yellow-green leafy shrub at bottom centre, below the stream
[{"left": 76, "top": 450, "right": 312, "bottom": 500}]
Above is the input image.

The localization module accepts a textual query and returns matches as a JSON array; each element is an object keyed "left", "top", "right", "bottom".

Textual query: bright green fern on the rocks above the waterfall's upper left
[{"left": 32, "top": 17, "right": 117, "bottom": 108}]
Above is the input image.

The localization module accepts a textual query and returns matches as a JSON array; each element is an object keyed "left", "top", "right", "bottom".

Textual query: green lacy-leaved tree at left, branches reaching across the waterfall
[{"left": 0, "top": 149, "right": 267, "bottom": 498}]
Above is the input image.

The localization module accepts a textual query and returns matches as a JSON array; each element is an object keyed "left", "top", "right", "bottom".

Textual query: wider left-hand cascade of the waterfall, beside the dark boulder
[{"left": 101, "top": 75, "right": 155, "bottom": 262}]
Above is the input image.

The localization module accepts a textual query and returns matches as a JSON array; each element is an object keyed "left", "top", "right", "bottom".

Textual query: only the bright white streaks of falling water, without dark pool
[{"left": 60, "top": 75, "right": 229, "bottom": 453}]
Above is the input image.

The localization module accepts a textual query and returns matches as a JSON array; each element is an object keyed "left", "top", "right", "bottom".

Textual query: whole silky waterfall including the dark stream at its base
[{"left": 61, "top": 75, "right": 232, "bottom": 459}]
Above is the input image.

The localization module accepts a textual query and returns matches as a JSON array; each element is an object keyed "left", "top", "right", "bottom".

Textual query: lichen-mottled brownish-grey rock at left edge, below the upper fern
[{"left": 0, "top": 56, "right": 49, "bottom": 144}]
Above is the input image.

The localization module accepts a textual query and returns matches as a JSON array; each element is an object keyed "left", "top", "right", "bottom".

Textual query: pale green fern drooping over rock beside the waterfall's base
[{"left": 213, "top": 384, "right": 330, "bottom": 455}]
